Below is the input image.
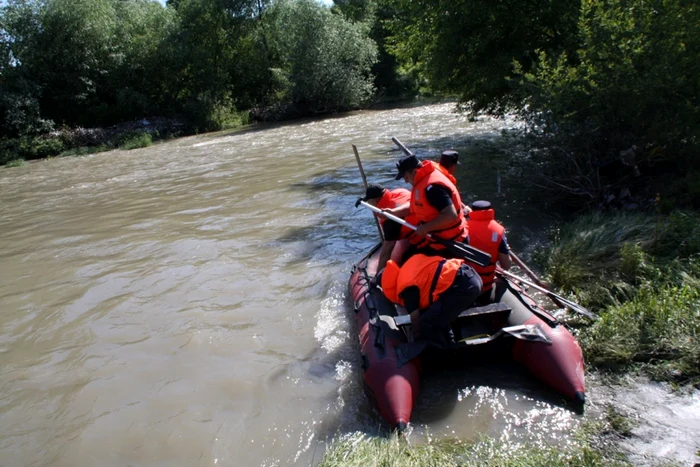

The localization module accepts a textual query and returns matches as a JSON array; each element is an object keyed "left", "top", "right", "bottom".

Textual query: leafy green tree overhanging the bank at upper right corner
[{"left": 520, "top": 0, "right": 700, "bottom": 207}]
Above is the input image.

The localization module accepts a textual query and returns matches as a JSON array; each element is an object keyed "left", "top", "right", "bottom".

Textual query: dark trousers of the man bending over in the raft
[{"left": 416, "top": 264, "right": 482, "bottom": 348}]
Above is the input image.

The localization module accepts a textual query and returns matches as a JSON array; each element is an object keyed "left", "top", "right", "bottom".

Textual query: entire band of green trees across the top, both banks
[{"left": 0, "top": 0, "right": 700, "bottom": 207}]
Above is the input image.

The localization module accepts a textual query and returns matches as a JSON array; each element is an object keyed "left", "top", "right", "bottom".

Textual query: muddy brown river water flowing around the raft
[{"left": 0, "top": 104, "right": 700, "bottom": 466}]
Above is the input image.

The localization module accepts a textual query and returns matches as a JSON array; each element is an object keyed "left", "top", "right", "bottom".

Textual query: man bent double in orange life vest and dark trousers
[{"left": 380, "top": 253, "right": 482, "bottom": 348}]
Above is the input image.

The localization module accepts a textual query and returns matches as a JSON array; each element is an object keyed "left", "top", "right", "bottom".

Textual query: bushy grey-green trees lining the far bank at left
[{"left": 0, "top": 0, "right": 377, "bottom": 163}]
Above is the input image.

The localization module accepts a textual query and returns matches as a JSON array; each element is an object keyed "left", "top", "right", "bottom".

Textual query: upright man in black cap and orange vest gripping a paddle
[{"left": 386, "top": 156, "right": 467, "bottom": 255}]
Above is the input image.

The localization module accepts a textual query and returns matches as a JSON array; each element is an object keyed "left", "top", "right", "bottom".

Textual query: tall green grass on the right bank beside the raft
[{"left": 539, "top": 212, "right": 700, "bottom": 386}]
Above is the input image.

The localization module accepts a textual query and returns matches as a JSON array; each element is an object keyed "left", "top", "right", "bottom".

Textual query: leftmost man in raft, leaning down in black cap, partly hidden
[{"left": 355, "top": 185, "right": 411, "bottom": 271}]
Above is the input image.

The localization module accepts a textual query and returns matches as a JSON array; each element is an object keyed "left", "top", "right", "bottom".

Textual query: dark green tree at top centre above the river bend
[{"left": 380, "top": 0, "right": 579, "bottom": 113}]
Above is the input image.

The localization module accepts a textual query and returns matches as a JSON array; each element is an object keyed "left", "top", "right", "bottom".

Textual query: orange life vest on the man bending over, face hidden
[{"left": 382, "top": 254, "right": 464, "bottom": 311}]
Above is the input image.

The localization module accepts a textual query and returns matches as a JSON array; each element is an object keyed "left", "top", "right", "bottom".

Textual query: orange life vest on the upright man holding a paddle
[{"left": 409, "top": 163, "right": 467, "bottom": 249}]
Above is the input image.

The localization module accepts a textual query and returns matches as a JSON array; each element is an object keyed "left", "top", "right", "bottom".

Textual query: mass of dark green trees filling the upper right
[{"left": 380, "top": 0, "right": 700, "bottom": 207}]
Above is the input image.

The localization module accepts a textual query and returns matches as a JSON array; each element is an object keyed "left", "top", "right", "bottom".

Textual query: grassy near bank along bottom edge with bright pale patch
[{"left": 317, "top": 378, "right": 700, "bottom": 467}]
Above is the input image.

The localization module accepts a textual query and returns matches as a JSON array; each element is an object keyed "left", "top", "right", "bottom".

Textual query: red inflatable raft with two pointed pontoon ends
[{"left": 349, "top": 245, "right": 585, "bottom": 430}]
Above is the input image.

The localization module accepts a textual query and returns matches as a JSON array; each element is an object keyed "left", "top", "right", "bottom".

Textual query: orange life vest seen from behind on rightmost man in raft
[{"left": 467, "top": 209, "right": 505, "bottom": 292}]
